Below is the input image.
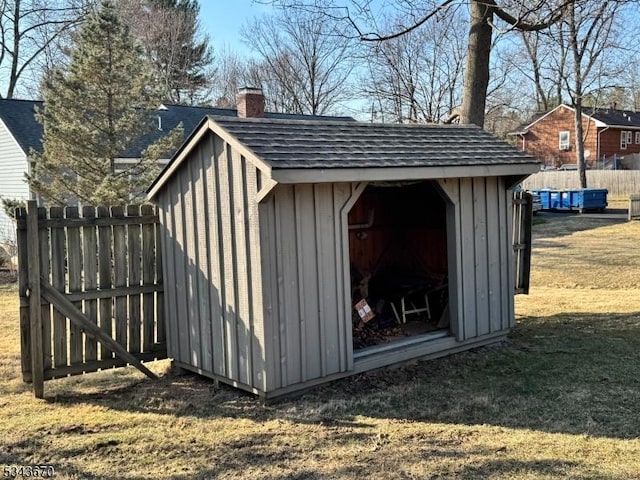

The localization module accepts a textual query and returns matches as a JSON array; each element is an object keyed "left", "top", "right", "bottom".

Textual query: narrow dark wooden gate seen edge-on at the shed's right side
[{"left": 513, "top": 191, "right": 533, "bottom": 294}]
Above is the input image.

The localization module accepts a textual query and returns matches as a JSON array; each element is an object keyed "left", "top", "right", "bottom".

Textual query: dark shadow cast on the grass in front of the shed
[{"left": 40, "top": 313, "right": 640, "bottom": 438}]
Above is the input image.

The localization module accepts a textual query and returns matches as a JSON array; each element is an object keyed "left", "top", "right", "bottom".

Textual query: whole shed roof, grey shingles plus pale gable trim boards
[{"left": 148, "top": 116, "right": 539, "bottom": 197}]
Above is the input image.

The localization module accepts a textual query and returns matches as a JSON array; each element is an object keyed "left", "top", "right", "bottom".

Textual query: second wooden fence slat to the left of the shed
[{"left": 127, "top": 205, "right": 142, "bottom": 353}]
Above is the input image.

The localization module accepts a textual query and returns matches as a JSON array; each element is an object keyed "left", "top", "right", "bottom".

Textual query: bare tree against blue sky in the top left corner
[{"left": 0, "top": 0, "right": 93, "bottom": 98}]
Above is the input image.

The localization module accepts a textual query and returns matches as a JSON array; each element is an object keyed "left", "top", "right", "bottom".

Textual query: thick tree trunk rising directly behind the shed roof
[{"left": 460, "top": 0, "right": 493, "bottom": 127}]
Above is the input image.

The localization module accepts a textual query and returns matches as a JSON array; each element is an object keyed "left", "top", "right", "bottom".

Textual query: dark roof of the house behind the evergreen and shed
[{"left": 0, "top": 99, "right": 355, "bottom": 158}]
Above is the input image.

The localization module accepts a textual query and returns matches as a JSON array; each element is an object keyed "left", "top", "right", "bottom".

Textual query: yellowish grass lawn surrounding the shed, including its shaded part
[{"left": 0, "top": 215, "right": 640, "bottom": 480}]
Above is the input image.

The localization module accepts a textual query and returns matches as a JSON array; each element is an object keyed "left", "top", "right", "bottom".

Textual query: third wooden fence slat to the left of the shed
[{"left": 111, "top": 207, "right": 129, "bottom": 348}]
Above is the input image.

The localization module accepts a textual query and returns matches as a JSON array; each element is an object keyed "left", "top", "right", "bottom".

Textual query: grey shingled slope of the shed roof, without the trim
[{"left": 210, "top": 117, "right": 538, "bottom": 169}]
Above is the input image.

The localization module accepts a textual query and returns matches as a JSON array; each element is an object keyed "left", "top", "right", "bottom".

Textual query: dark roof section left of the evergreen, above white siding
[{"left": 0, "top": 98, "right": 42, "bottom": 153}]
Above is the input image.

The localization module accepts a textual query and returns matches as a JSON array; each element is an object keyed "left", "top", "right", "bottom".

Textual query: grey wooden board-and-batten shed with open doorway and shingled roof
[{"left": 148, "top": 116, "right": 539, "bottom": 397}]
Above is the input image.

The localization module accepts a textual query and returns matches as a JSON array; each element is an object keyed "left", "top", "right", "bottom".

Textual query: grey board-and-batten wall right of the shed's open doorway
[{"left": 438, "top": 177, "right": 515, "bottom": 341}]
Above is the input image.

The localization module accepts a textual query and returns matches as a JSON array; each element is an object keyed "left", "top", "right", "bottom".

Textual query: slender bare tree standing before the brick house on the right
[{"left": 520, "top": 0, "right": 637, "bottom": 188}]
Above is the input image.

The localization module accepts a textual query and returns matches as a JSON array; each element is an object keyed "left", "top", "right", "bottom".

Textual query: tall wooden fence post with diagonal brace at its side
[{"left": 27, "top": 200, "right": 44, "bottom": 398}]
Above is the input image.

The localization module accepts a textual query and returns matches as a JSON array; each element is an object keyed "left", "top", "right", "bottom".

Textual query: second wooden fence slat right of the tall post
[{"left": 49, "top": 207, "right": 67, "bottom": 367}]
